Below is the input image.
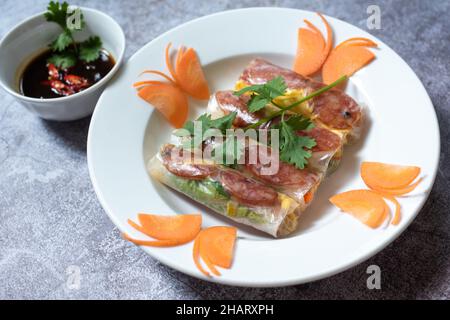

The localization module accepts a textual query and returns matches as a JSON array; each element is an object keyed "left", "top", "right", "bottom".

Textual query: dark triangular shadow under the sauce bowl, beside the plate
[{"left": 41, "top": 116, "right": 91, "bottom": 153}]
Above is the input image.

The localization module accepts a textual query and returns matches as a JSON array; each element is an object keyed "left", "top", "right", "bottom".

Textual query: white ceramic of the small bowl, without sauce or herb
[{"left": 0, "top": 8, "right": 125, "bottom": 121}]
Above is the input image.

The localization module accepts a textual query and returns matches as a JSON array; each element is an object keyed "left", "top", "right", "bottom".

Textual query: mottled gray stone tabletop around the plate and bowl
[{"left": 0, "top": 0, "right": 450, "bottom": 299}]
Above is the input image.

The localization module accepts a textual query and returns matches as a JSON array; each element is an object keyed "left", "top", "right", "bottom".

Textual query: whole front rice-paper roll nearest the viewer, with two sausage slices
[{"left": 148, "top": 144, "right": 299, "bottom": 237}]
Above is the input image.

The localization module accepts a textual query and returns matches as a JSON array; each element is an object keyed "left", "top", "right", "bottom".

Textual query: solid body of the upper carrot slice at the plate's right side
[{"left": 360, "top": 161, "right": 420, "bottom": 189}]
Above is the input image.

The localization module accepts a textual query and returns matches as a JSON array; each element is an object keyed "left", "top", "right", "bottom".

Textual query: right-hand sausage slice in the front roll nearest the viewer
[{"left": 220, "top": 170, "right": 278, "bottom": 206}]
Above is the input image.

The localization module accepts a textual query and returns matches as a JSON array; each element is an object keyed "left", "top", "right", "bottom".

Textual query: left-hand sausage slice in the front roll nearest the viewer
[{"left": 160, "top": 144, "right": 217, "bottom": 180}]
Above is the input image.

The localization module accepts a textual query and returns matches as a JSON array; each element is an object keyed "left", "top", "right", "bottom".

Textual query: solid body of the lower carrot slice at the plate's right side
[{"left": 329, "top": 190, "right": 386, "bottom": 228}]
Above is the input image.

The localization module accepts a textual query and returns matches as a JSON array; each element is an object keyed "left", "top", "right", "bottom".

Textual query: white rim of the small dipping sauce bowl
[{"left": 0, "top": 6, "right": 126, "bottom": 105}]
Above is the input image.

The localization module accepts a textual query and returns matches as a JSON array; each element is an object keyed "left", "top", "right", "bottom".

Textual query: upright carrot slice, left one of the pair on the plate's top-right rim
[{"left": 294, "top": 13, "right": 333, "bottom": 76}]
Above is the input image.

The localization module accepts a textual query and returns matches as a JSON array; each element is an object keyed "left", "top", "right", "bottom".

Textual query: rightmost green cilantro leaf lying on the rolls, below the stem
[{"left": 279, "top": 121, "right": 316, "bottom": 169}]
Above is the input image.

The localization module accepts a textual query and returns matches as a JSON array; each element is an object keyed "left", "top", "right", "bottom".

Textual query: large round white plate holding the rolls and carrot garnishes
[{"left": 88, "top": 8, "right": 440, "bottom": 287}]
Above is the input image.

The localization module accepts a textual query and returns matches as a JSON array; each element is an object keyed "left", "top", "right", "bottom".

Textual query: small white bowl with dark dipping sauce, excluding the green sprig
[{"left": 0, "top": 2, "right": 125, "bottom": 121}]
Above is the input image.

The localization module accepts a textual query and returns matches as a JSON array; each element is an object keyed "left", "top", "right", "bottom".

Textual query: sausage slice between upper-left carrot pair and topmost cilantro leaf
[{"left": 216, "top": 91, "right": 261, "bottom": 127}]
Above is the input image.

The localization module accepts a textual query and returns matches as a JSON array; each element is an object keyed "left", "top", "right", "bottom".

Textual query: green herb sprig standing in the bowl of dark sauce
[{"left": 44, "top": 1, "right": 102, "bottom": 69}]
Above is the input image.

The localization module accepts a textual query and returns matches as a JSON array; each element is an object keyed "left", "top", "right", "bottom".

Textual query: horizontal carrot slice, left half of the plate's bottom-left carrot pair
[{"left": 124, "top": 214, "right": 202, "bottom": 247}]
